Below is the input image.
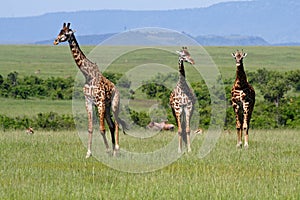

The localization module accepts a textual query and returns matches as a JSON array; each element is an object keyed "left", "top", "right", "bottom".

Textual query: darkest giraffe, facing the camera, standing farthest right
[{"left": 231, "top": 50, "right": 255, "bottom": 148}]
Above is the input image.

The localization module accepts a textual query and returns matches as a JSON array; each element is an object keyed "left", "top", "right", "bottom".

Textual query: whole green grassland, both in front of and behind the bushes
[{"left": 0, "top": 45, "right": 300, "bottom": 200}]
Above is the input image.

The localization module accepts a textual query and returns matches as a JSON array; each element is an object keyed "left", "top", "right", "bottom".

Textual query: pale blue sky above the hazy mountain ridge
[{"left": 0, "top": 0, "right": 246, "bottom": 17}]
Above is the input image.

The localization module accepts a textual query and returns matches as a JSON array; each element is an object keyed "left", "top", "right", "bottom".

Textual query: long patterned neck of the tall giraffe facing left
[{"left": 68, "top": 34, "right": 102, "bottom": 81}]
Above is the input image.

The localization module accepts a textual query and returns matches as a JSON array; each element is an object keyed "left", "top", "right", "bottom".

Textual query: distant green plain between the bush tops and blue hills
[{"left": 0, "top": 45, "right": 300, "bottom": 78}]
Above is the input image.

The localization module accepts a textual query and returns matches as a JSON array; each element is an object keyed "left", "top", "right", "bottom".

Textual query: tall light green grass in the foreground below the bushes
[{"left": 0, "top": 130, "right": 300, "bottom": 199}]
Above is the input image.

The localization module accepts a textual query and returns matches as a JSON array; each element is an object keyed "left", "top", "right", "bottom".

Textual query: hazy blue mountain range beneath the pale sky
[{"left": 0, "top": 0, "right": 300, "bottom": 45}]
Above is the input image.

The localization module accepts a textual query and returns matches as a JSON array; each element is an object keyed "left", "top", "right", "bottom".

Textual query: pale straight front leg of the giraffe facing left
[{"left": 85, "top": 98, "right": 93, "bottom": 158}]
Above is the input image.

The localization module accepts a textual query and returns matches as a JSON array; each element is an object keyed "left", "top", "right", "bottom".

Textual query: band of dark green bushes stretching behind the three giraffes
[{"left": 0, "top": 68, "right": 300, "bottom": 130}]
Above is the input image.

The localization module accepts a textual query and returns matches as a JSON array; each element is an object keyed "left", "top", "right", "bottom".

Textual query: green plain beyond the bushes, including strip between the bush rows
[{"left": 0, "top": 45, "right": 300, "bottom": 116}]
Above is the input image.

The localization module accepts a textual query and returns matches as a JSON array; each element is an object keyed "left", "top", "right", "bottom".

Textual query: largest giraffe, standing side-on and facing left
[{"left": 53, "top": 23, "right": 126, "bottom": 158}]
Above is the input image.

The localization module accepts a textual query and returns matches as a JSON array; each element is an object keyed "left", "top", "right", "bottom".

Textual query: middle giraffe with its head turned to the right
[{"left": 170, "top": 47, "right": 196, "bottom": 153}]
